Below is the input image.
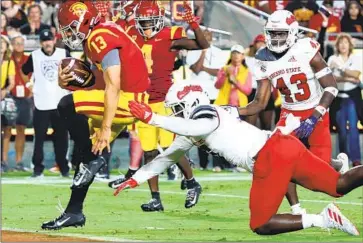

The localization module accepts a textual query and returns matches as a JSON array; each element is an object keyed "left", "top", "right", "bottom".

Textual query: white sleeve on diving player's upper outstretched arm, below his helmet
[{"left": 151, "top": 108, "right": 219, "bottom": 137}]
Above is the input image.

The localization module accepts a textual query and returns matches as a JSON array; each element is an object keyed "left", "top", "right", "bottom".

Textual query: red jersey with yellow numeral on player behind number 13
[{"left": 127, "top": 26, "right": 186, "bottom": 103}]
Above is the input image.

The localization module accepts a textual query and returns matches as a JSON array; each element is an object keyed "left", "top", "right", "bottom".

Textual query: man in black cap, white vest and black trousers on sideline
[{"left": 22, "top": 29, "right": 69, "bottom": 177}]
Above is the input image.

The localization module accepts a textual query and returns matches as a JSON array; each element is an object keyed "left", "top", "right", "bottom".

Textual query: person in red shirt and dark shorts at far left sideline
[{"left": 4, "top": 35, "right": 32, "bottom": 171}]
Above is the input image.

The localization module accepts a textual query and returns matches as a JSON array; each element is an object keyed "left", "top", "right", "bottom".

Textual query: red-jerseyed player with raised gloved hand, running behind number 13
[{"left": 109, "top": 1, "right": 209, "bottom": 211}]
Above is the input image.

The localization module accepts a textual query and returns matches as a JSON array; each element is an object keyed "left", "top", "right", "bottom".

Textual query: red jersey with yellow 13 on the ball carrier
[{"left": 84, "top": 22, "right": 150, "bottom": 93}]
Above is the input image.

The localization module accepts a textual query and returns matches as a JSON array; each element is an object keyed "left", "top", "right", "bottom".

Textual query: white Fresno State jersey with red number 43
[{"left": 254, "top": 38, "right": 323, "bottom": 110}]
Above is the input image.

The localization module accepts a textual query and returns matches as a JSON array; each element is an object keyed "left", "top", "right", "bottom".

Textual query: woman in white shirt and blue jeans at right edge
[{"left": 328, "top": 33, "right": 363, "bottom": 166}]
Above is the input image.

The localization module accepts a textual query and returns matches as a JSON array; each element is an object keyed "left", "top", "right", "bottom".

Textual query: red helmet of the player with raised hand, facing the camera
[{"left": 135, "top": 1, "right": 165, "bottom": 38}]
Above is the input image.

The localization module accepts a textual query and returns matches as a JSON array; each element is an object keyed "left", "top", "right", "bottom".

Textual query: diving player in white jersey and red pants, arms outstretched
[{"left": 114, "top": 81, "right": 363, "bottom": 235}]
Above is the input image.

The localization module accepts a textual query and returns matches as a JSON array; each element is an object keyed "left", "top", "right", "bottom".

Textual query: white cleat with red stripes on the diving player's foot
[{"left": 320, "top": 203, "right": 359, "bottom": 236}]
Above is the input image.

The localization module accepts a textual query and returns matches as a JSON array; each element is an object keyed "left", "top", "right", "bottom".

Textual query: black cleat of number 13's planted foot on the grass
[{"left": 42, "top": 212, "right": 86, "bottom": 230}]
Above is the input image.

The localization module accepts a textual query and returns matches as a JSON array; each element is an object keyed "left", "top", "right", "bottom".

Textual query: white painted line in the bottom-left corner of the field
[{"left": 1, "top": 227, "right": 145, "bottom": 242}]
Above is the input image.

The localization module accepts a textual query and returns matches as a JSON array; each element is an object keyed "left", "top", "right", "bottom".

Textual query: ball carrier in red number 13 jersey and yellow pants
[{"left": 42, "top": 1, "right": 150, "bottom": 229}]
